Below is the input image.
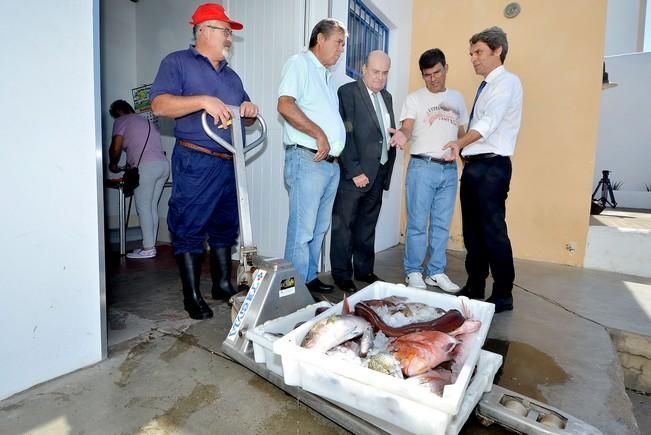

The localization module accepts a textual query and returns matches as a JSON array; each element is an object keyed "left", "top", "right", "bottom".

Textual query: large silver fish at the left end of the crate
[{"left": 301, "top": 314, "right": 373, "bottom": 352}]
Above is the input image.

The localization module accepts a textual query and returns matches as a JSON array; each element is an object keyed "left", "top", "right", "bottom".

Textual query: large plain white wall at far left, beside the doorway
[{"left": 0, "top": 0, "right": 106, "bottom": 399}]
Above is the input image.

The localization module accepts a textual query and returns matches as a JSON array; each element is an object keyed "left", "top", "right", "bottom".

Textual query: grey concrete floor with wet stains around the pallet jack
[{"left": 0, "top": 246, "right": 651, "bottom": 435}]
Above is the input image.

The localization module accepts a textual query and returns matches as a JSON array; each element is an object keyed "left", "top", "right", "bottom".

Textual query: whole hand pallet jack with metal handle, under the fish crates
[{"left": 201, "top": 106, "right": 601, "bottom": 435}]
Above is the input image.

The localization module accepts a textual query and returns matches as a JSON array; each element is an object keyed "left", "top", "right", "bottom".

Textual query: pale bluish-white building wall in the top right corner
[{"left": 604, "top": 0, "right": 647, "bottom": 56}]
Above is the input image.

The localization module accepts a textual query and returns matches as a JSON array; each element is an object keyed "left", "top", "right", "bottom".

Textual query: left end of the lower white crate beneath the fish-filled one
[{"left": 246, "top": 302, "right": 332, "bottom": 376}]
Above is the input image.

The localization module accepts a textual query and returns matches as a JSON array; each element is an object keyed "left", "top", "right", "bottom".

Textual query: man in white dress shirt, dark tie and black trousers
[{"left": 445, "top": 27, "right": 522, "bottom": 313}]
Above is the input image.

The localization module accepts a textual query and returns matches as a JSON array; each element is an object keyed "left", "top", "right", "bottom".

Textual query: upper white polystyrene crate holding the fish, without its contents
[{"left": 273, "top": 282, "right": 495, "bottom": 424}]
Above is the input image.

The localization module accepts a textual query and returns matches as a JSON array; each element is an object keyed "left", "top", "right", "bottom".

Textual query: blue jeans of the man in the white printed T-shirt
[{"left": 404, "top": 159, "right": 457, "bottom": 276}]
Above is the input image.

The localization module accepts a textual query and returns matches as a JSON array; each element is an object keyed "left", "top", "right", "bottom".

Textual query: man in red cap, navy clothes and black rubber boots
[{"left": 150, "top": 3, "right": 258, "bottom": 319}]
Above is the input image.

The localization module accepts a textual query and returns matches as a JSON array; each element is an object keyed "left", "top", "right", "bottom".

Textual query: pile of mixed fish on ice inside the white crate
[{"left": 301, "top": 296, "right": 481, "bottom": 395}]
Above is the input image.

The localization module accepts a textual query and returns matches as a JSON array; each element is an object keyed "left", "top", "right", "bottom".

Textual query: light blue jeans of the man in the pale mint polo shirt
[{"left": 285, "top": 148, "right": 339, "bottom": 283}]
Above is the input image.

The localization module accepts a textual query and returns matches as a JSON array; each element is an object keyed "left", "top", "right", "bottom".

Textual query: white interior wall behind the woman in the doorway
[{"left": 101, "top": 0, "right": 192, "bottom": 237}]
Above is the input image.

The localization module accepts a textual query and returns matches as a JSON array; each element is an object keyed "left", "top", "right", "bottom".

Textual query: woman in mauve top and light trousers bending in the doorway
[{"left": 109, "top": 100, "right": 170, "bottom": 258}]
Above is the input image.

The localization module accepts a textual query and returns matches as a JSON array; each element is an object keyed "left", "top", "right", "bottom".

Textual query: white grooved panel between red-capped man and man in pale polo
[{"left": 225, "top": 0, "right": 305, "bottom": 257}]
